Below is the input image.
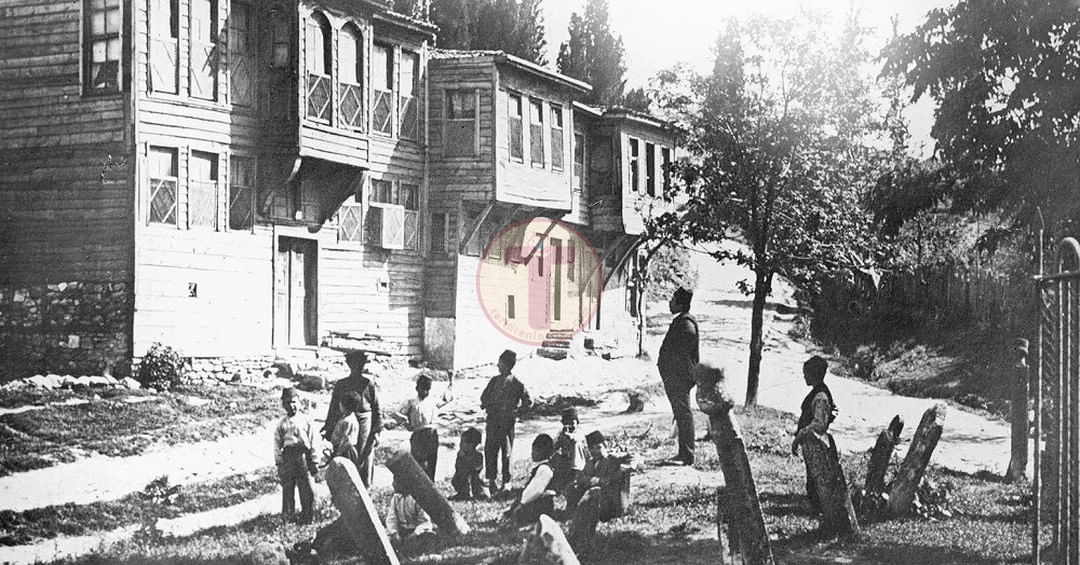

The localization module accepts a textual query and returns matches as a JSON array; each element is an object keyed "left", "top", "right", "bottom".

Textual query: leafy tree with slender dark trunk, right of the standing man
[{"left": 650, "top": 14, "right": 883, "bottom": 405}]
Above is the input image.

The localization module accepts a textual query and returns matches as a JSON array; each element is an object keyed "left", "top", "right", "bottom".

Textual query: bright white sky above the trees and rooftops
[{"left": 543, "top": 0, "right": 955, "bottom": 154}]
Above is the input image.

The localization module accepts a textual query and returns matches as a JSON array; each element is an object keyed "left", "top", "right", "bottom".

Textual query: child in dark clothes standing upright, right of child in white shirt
[{"left": 480, "top": 349, "right": 532, "bottom": 496}]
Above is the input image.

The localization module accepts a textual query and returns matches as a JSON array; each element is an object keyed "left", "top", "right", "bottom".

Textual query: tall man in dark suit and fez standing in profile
[{"left": 657, "top": 286, "right": 699, "bottom": 465}]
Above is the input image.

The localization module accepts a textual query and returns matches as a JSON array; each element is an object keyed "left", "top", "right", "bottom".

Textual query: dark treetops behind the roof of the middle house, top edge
[{"left": 425, "top": 0, "right": 548, "bottom": 65}]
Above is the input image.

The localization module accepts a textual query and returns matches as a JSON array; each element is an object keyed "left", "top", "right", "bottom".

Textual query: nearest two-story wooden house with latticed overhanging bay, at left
[{"left": 0, "top": 0, "right": 434, "bottom": 380}]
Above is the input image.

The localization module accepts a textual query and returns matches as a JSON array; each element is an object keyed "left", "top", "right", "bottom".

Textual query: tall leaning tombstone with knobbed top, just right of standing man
[{"left": 692, "top": 363, "right": 773, "bottom": 565}]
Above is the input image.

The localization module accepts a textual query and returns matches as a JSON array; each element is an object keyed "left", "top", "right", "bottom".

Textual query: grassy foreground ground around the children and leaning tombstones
[{"left": 42, "top": 408, "right": 1030, "bottom": 565}]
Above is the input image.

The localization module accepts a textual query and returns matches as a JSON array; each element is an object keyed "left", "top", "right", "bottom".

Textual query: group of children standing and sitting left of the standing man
[{"left": 274, "top": 350, "right": 626, "bottom": 550}]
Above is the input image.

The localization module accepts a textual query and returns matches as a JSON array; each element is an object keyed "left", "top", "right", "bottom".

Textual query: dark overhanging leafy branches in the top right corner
[{"left": 883, "top": 0, "right": 1080, "bottom": 232}]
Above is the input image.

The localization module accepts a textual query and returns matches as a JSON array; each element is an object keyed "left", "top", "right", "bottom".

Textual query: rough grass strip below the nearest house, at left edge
[{"left": 0, "top": 386, "right": 281, "bottom": 476}]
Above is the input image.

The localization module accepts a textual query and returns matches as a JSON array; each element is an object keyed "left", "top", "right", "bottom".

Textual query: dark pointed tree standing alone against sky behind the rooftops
[{"left": 556, "top": 0, "right": 626, "bottom": 105}]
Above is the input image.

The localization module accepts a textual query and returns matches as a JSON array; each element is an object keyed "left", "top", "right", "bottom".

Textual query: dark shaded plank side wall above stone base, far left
[{"left": 0, "top": 0, "right": 132, "bottom": 284}]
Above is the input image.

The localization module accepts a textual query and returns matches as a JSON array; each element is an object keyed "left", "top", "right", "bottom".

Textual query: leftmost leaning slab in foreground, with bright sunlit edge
[{"left": 326, "top": 457, "right": 400, "bottom": 565}]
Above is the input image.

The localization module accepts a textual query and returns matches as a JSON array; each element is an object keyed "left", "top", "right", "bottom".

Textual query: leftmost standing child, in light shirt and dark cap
[{"left": 273, "top": 388, "right": 319, "bottom": 524}]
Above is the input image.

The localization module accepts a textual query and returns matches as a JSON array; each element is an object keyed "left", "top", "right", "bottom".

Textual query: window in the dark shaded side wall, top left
[{"left": 82, "top": 0, "right": 123, "bottom": 93}]
